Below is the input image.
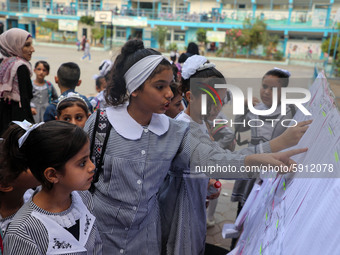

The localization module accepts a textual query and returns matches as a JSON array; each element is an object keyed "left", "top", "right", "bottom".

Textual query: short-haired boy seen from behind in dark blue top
[{"left": 44, "top": 62, "right": 93, "bottom": 122}]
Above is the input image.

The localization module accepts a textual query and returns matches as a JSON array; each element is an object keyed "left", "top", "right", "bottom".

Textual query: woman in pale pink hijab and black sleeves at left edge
[{"left": 0, "top": 28, "right": 34, "bottom": 135}]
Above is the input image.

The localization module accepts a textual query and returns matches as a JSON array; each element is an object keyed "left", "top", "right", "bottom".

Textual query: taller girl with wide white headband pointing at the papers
[{"left": 85, "top": 40, "right": 305, "bottom": 255}]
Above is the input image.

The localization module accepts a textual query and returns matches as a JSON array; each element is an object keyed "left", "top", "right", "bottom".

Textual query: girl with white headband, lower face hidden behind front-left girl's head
[{"left": 57, "top": 92, "right": 90, "bottom": 128}]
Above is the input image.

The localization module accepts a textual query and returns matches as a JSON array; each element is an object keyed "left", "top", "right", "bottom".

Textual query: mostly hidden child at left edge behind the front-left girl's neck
[{"left": 0, "top": 134, "right": 40, "bottom": 240}]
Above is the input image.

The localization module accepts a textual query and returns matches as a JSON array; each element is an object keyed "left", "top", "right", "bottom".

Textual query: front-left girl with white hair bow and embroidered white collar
[{"left": 4, "top": 121, "right": 101, "bottom": 255}]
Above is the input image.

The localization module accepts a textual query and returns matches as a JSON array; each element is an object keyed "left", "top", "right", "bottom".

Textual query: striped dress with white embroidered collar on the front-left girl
[{"left": 4, "top": 191, "right": 102, "bottom": 255}]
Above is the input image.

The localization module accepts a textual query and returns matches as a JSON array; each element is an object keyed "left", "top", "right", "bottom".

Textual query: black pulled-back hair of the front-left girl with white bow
[{"left": 0, "top": 120, "right": 88, "bottom": 189}]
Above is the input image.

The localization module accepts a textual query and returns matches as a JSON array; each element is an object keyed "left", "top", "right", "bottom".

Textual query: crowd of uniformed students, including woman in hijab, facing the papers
[{"left": 0, "top": 29, "right": 310, "bottom": 255}]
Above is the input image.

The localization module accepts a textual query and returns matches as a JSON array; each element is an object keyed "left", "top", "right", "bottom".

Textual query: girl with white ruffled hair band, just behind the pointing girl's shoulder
[{"left": 159, "top": 55, "right": 312, "bottom": 254}]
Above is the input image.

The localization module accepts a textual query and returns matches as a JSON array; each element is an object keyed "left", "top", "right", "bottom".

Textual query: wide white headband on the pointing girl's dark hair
[{"left": 124, "top": 55, "right": 165, "bottom": 94}]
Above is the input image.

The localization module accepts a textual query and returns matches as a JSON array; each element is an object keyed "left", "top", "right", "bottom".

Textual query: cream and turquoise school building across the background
[{"left": 0, "top": 0, "right": 340, "bottom": 59}]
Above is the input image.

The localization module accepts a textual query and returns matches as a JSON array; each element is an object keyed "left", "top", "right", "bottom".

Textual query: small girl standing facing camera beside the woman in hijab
[{"left": 31, "top": 60, "right": 58, "bottom": 122}]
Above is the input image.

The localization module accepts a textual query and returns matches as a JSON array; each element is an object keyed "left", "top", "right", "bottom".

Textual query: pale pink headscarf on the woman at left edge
[{"left": 0, "top": 28, "right": 31, "bottom": 58}]
